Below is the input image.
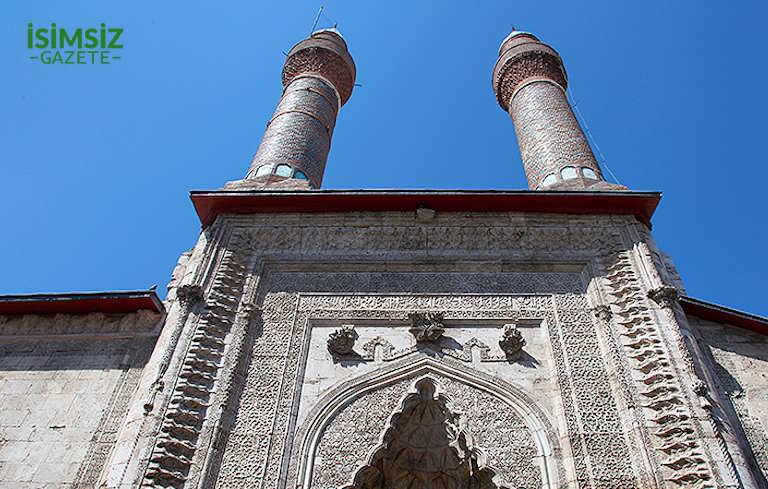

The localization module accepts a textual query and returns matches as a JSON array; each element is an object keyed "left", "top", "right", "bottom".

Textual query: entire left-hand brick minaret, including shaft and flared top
[{"left": 235, "top": 29, "right": 355, "bottom": 188}]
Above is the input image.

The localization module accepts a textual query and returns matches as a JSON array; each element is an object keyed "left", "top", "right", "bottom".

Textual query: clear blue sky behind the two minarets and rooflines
[{"left": 0, "top": 0, "right": 768, "bottom": 315}]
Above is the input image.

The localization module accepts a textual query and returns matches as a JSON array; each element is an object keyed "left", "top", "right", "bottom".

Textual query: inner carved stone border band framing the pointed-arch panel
[{"left": 214, "top": 282, "right": 637, "bottom": 487}]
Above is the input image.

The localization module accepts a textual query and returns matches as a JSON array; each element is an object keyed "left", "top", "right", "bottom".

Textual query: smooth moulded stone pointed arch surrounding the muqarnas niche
[{"left": 292, "top": 353, "right": 562, "bottom": 489}]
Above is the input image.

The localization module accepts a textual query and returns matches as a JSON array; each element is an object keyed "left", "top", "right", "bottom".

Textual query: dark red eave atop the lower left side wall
[{"left": 0, "top": 290, "right": 165, "bottom": 315}]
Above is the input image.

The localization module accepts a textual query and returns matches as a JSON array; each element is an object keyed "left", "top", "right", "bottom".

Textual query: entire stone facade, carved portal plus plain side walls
[{"left": 6, "top": 212, "right": 767, "bottom": 489}]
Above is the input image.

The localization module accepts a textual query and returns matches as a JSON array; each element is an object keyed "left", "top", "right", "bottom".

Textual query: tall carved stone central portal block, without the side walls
[{"left": 73, "top": 212, "right": 761, "bottom": 489}]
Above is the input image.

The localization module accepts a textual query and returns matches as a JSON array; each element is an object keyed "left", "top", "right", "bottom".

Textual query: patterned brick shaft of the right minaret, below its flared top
[{"left": 509, "top": 82, "right": 603, "bottom": 189}]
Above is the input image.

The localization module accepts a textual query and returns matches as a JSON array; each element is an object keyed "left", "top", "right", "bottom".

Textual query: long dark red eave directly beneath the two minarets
[{"left": 190, "top": 190, "right": 661, "bottom": 228}]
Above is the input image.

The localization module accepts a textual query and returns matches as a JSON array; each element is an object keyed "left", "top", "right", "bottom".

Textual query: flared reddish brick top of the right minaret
[{"left": 492, "top": 30, "right": 568, "bottom": 112}]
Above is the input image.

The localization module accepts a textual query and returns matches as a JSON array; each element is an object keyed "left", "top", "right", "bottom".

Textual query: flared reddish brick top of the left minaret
[{"left": 283, "top": 28, "right": 356, "bottom": 105}]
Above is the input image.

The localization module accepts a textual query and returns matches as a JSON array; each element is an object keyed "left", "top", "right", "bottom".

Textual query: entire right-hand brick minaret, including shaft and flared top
[{"left": 493, "top": 31, "right": 625, "bottom": 190}]
